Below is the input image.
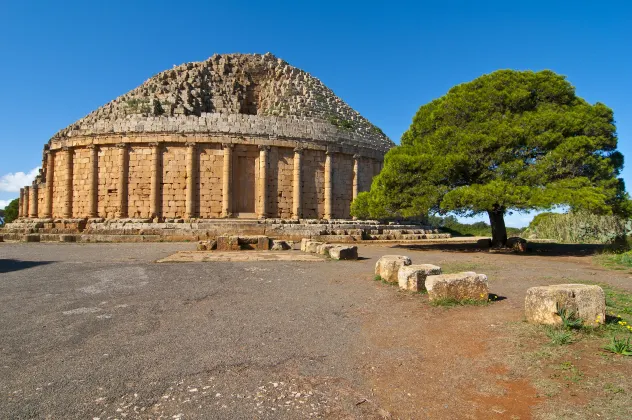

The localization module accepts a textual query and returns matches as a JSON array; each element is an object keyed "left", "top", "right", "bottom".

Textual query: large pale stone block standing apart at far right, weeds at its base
[{"left": 524, "top": 284, "right": 606, "bottom": 326}]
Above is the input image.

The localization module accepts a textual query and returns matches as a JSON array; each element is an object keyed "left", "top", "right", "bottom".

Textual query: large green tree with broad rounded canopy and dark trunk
[{"left": 352, "top": 70, "right": 632, "bottom": 245}]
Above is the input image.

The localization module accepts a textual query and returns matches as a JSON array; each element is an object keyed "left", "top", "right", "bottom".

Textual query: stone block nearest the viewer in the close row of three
[{"left": 425, "top": 271, "right": 489, "bottom": 301}]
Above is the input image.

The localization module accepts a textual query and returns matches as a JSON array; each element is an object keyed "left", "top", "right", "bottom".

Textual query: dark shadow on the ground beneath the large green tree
[{"left": 393, "top": 242, "right": 611, "bottom": 257}]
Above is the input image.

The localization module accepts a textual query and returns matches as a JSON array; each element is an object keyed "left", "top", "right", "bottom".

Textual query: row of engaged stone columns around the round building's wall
[{"left": 18, "top": 143, "right": 381, "bottom": 219}]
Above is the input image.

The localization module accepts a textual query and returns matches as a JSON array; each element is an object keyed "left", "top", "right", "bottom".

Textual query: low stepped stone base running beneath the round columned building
[{"left": 0, "top": 218, "right": 450, "bottom": 243}]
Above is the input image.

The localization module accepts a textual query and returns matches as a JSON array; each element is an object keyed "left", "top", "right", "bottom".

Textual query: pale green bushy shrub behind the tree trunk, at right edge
[{"left": 525, "top": 211, "right": 632, "bottom": 244}]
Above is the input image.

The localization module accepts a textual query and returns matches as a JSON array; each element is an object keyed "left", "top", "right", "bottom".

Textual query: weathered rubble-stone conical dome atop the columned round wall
[{"left": 52, "top": 53, "right": 394, "bottom": 153}]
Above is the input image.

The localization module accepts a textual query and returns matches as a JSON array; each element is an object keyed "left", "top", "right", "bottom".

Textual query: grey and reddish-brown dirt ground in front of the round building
[{"left": 0, "top": 243, "right": 632, "bottom": 419}]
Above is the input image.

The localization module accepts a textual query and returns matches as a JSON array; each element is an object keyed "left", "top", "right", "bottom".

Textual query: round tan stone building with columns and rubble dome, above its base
[{"left": 20, "top": 54, "right": 394, "bottom": 221}]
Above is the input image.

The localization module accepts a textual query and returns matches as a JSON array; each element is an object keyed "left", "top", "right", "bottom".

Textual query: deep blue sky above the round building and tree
[{"left": 0, "top": 0, "right": 632, "bottom": 225}]
